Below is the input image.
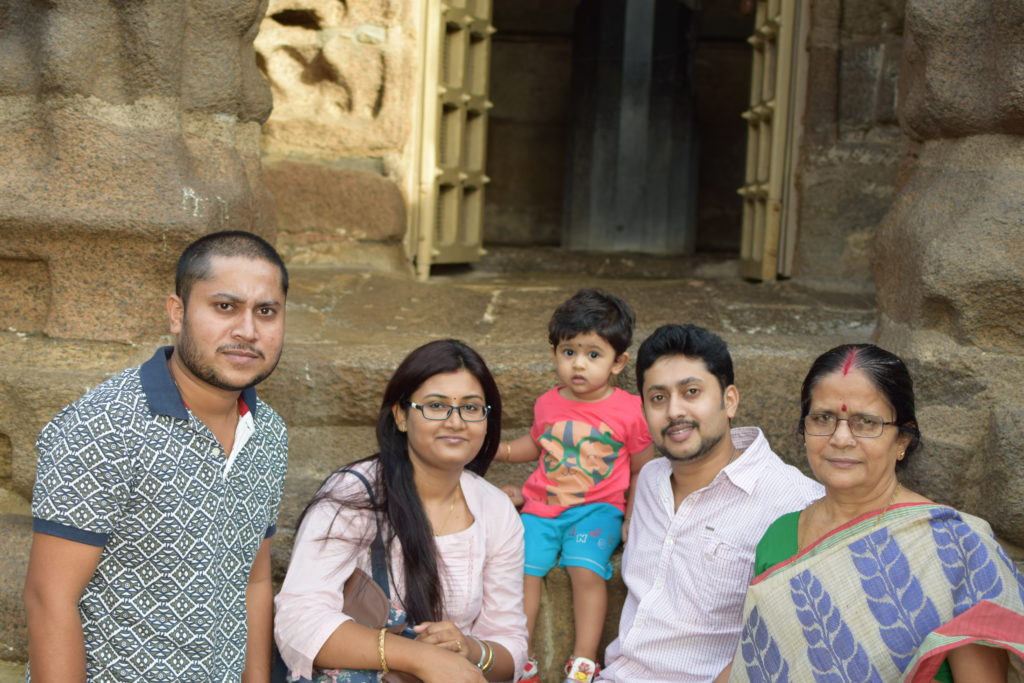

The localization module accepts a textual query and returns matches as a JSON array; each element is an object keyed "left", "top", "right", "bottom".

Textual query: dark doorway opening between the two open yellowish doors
[{"left": 484, "top": 0, "right": 753, "bottom": 254}]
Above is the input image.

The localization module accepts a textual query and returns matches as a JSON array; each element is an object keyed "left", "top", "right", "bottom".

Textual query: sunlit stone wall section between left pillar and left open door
[{"left": 256, "top": 0, "right": 411, "bottom": 269}]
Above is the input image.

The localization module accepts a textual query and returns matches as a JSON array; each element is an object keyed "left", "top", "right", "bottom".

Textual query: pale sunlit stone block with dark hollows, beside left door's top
[{"left": 255, "top": 0, "right": 411, "bottom": 159}]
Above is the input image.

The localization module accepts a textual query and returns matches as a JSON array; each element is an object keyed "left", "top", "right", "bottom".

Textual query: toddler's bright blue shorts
[{"left": 522, "top": 503, "right": 623, "bottom": 581}]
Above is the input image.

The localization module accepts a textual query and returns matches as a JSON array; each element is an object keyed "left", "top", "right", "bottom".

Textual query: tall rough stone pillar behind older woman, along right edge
[{"left": 874, "top": 0, "right": 1024, "bottom": 545}]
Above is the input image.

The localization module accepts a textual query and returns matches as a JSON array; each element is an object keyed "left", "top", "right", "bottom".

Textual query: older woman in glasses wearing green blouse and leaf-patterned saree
[{"left": 729, "top": 344, "right": 1024, "bottom": 683}]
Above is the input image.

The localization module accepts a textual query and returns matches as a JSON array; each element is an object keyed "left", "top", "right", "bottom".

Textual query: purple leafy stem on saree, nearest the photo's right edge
[{"left": 931, "top": 509, "right": 1002, "bottom": 616}]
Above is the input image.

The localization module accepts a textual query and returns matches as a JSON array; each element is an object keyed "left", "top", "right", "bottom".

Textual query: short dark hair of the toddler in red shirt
[{"left": 548, "top": 288, "right": 636, "bottom": 356}]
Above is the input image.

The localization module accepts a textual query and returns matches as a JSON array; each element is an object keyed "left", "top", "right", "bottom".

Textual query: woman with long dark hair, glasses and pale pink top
[{"left": 274, "top": 340, "right": 526, "bottom": 683}]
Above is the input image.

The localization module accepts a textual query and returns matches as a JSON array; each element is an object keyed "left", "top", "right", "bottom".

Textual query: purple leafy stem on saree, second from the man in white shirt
[{"left": 790, "top": 569, "right": 882, "bottom": 683}]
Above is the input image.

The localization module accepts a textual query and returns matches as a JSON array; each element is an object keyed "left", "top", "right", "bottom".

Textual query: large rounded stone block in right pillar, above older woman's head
[{"left": 874, "top": 135, "right": 1024, "bottom": 351}]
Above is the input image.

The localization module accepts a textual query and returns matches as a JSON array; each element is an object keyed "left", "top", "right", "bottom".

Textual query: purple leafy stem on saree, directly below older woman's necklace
[{"left": 849, "top": 527, "right": 942, "bottom": 671}]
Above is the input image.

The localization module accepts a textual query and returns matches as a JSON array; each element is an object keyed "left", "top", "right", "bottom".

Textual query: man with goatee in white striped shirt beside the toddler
[{"left": 599, "top": 325, "right": 823, "bottom": 683}]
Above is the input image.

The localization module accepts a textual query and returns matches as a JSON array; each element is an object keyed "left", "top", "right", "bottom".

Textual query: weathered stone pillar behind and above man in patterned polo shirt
[{"left": 0, "top": 0, "right": 273, "bottom": 341}]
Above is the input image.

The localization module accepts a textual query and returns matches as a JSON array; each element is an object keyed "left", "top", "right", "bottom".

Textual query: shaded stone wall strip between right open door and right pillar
[{"left": 794, "top": 0, "right": 905, "bottom": 288}]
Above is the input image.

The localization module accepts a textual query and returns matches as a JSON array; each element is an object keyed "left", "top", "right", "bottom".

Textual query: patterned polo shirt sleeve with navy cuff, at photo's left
[{"left": 32, "top": 397, "right": 130, "bottom": 547}]
